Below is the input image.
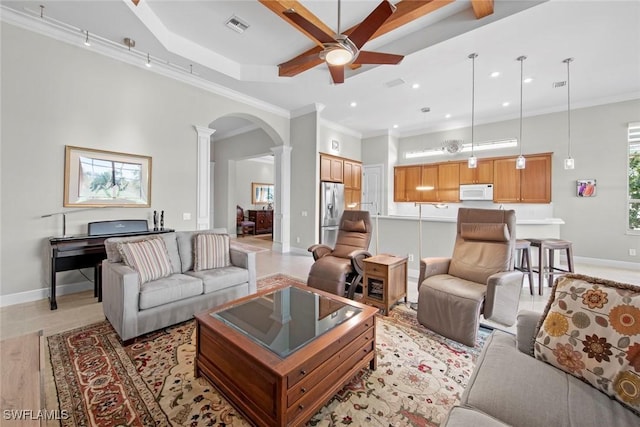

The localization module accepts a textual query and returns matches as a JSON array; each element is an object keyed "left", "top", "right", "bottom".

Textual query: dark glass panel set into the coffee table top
[{"left": 211, "top": 287, "right": 362, "bottom": 357}]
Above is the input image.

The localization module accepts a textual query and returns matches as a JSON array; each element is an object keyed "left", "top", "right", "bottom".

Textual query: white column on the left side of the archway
[{"left": 193, "top": 125, "right": 216, "bottom": 230}]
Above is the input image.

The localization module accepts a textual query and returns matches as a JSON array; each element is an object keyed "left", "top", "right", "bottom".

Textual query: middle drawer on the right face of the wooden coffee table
[{"left": 287, "top": 328, "right": 375, "bottom": 406}]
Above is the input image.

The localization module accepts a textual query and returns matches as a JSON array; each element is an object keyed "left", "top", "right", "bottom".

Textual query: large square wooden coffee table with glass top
[{"left": 195, "top": 285, "right": 378, "bottom": 426}]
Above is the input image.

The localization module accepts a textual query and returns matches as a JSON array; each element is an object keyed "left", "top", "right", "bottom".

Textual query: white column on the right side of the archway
[{"left": 271, "top": 145, "right": 292, "bottom": 253}]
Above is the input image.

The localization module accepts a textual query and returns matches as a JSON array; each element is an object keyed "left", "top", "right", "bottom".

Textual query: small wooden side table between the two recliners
[{"left": 362, "top": 254, "right": 407, "bottom": 316}]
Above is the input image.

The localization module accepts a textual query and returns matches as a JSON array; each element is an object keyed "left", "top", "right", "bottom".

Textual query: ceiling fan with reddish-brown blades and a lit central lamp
[{"left": 281, "top": 0, "right": 404, "bottom": 84}]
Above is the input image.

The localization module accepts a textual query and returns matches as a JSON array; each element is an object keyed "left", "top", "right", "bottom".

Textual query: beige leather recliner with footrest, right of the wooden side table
[{"left": 417, "top": 208, "right": 524, "bottom": 346}]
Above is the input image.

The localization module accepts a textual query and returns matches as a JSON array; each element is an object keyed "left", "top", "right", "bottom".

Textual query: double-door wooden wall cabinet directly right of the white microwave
[{"left": 493, "top": 153, "right": 551, "bottom": 203}]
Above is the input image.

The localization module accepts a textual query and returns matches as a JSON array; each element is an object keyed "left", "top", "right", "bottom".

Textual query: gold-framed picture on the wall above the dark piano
[{"left": 63, "top": 145, "right": 151, "bottom": 208}]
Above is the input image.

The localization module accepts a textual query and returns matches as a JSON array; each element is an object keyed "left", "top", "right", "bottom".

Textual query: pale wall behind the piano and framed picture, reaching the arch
[{"left": 0, "top": 23, "right": 289, "bottom": 298}]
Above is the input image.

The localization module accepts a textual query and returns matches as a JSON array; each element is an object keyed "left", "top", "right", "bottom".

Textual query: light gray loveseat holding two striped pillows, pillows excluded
[{"left": 102, "top": 229, "right": 256, "bottom": 341}]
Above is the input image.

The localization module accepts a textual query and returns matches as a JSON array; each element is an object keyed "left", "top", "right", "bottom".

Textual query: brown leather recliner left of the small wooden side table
[{"left": 307, "top": 211, "right": 372, "bottom": 299}]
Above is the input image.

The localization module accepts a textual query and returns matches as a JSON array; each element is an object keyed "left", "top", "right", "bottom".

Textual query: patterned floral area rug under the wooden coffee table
[{"left": 48, "top": 275, "right": 488, "bottom": 427}]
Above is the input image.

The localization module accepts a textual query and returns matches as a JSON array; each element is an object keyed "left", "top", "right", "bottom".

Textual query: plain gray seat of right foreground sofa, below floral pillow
[{"left": 461, "top": 330, "right": 638, "bottom": 427}]
